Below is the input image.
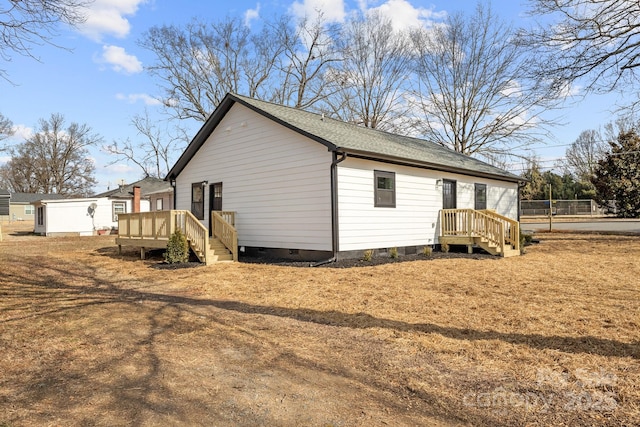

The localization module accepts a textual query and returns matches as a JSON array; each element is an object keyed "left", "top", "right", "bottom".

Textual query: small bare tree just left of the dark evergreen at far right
[{"left": 564, "top": 129, "right": 607, "bottom": 183}]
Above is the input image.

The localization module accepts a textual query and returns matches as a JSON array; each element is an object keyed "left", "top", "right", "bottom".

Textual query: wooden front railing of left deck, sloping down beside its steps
[{"left": 118, "top": 210, "right": 209, "bottom": 263}]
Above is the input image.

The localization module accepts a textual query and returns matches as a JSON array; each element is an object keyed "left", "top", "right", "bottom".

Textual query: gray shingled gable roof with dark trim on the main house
[{"left": 167, "top": 94, "right": 522, "bottom": 182}]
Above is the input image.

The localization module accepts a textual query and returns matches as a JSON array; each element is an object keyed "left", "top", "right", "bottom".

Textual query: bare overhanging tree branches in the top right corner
[{"left": 528, "top": 0, "right": 640, "bottom": 103}]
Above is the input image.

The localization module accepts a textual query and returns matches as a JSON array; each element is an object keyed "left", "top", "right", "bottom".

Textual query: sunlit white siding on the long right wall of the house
[{"left": 338, "top": 158, "right": 518, "bottom": 251}]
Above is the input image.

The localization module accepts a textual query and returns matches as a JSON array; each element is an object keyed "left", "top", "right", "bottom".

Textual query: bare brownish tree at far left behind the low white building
[{"left": 0, "top": 114, "right": 101, "bottom": 196}]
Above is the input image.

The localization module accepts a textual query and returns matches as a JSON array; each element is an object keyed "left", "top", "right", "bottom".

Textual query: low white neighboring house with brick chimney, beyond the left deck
[{"left": 35, "top": 178, "right": 172, "bottom": 236}]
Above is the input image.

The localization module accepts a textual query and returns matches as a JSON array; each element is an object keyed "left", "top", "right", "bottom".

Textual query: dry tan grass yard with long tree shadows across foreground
[{"left": 0, "top": 226, "right": 640, "bottom": 427}]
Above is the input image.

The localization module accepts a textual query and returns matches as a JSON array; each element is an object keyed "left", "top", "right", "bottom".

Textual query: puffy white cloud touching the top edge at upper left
[{"left": 79, "top": 0, "right": 147, "bottom": 41}]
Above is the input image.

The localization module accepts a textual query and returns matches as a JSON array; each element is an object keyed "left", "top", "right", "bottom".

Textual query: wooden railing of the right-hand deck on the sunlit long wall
[{"left": 440, "top": 209, "right": 520, "bottom": 252}]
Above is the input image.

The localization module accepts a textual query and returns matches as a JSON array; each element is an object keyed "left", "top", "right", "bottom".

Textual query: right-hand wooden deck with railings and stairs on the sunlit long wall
[{"left": 440, "top": 209, "right": 520, "bottom": 257}]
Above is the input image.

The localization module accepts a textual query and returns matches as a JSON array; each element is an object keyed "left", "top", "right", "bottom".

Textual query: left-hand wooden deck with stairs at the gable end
[{"left": 116, "top": 210, "right": 238, "bottom": 265}]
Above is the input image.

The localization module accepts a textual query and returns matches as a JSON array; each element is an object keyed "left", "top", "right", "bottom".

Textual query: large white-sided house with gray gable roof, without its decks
[{"left": 166, "top": 94, "right": 521, "bottom": 259}]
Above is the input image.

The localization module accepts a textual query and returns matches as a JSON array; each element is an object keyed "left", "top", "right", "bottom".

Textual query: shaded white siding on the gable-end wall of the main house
[{"left": 175, "top": 103, "right": 332, "bottom": 251}]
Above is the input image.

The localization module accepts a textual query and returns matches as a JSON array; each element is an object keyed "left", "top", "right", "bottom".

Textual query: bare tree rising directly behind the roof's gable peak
[{"left": 140, "top": 18, "right": 282, "bottom": 121}]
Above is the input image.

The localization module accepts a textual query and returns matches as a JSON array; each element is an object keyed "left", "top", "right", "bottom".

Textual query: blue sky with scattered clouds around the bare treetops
[{"left": 0, "top": 0, "right": 623, "bottom": 192}]
